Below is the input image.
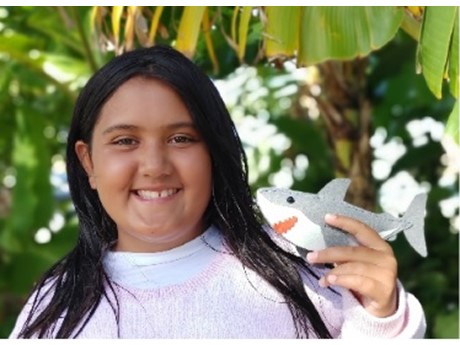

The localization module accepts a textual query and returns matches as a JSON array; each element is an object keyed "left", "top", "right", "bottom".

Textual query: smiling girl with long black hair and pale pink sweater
[{"left": 11, "top": 46, "right": 425, "bottom": 338}]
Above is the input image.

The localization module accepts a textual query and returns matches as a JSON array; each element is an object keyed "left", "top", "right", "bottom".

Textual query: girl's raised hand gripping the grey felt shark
[{"left": 307, "top": 214, "right": 398, "bottom": 317}]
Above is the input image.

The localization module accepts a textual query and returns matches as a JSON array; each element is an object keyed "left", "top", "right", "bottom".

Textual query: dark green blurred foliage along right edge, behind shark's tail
[{"left": 362, "top": 30, "right": 459, "bottom": 338}]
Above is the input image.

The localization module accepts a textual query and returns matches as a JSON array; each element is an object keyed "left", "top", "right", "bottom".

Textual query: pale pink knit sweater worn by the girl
[{"left": 10, "top": 226, "right": 426, "bottom": 338}]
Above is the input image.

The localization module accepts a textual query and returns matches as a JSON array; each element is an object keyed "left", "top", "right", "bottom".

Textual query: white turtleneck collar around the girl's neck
[{"left": 104, "top": 226, "right": 223, "bottom": 289}]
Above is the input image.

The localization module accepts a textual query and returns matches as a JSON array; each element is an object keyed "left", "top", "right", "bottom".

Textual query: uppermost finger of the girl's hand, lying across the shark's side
[{"left": 325, "top": 214, "right": 392, "bottom": 252}]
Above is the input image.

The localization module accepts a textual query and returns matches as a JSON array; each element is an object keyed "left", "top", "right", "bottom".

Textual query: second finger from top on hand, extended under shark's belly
[{"left": 307, "top": 246, "right": 397, "bottom": 271}]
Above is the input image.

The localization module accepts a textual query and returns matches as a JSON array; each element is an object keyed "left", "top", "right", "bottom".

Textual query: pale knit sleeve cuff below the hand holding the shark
[{"left": 339, "top": 281, "right": 426, "bottom": 339}]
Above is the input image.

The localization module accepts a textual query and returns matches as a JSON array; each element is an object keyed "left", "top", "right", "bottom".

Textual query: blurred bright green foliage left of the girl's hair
[{"left": 0, "top": 7, "right": 101, "bottom": 337}]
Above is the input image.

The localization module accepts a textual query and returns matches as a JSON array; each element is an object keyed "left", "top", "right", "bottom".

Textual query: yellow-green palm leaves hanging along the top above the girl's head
[{"left": 90, "top": 6, "right": 458, "bottom": 142}]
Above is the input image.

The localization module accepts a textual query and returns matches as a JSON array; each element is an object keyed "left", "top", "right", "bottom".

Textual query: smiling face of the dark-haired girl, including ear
[{"left": 75, "top": 77, "right": 212, "bottom": 252}]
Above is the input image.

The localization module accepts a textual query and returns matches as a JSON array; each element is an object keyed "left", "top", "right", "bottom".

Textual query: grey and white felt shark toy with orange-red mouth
[{"left": 256, "top": 178, "right": 427, "bottom": 257}]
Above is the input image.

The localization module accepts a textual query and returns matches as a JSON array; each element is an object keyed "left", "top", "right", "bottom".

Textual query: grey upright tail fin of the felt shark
[{"left": 402, "top": 194, "right": 428, "bottom": 257}]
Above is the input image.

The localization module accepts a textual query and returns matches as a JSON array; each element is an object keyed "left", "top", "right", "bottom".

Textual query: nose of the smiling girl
[{"left": 138, "top": 143, "right": 172, "bottom": 178}]
